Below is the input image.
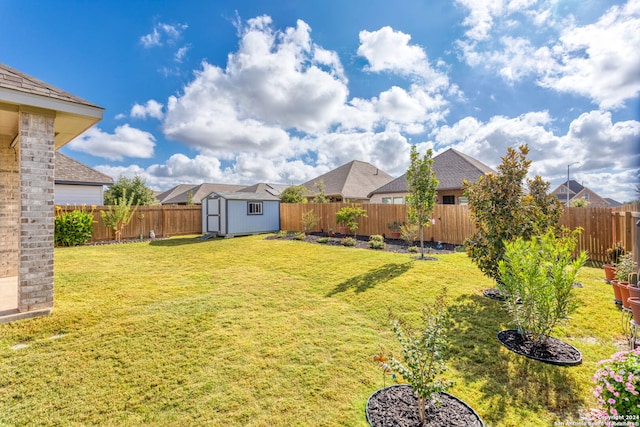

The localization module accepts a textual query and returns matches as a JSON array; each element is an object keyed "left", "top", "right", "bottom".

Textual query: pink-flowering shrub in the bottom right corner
[{"left": 593, "top": 348, "right": 640, "bottom": 425}]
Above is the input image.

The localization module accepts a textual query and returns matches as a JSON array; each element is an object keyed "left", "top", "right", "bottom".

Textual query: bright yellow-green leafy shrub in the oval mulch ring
[{"left": 498, "top": 229, "right": 587, "bottom": 345}]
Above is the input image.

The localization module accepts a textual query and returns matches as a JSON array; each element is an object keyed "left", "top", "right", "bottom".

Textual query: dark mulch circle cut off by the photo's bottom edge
[{"left": 366, "top": 384, "right": 484, "bottom": 427}]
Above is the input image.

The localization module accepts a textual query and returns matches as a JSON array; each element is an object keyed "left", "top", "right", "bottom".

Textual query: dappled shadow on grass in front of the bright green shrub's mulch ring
[{"left": 447, "top": 295, "right": 584, "bottom": 425}]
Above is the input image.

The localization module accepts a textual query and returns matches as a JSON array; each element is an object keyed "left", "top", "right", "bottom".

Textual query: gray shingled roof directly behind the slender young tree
[{"left": 369, "top": 148, "right": 495, "bottom": 196}]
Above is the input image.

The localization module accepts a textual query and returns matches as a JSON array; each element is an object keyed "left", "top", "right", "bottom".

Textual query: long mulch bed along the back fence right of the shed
[{"left": 266, "top": 233, "right": 458, "bottom": 260}]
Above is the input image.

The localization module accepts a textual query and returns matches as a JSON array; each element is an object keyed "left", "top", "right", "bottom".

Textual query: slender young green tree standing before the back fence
[{"left": 407, "top": 145, "right": 438, "bottom": 258}]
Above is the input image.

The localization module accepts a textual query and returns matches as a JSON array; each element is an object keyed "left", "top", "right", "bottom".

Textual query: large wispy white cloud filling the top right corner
[{"left": 457, "top": 0, "right": 640, "bottom": 109}]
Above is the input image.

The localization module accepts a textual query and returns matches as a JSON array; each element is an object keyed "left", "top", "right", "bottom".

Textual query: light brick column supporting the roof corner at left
[{"left": 18, "top": 111, "right": 54, "bottom": 312}]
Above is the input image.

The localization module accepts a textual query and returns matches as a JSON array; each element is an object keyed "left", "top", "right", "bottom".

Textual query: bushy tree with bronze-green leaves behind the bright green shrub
[{"left": 464, "top": 145, "right": 562, "bottom": 282}]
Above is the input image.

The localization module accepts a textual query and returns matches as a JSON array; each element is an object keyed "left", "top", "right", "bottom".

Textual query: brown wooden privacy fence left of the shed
[{"left": 60, "top": 205, "right": 202, "bottom": 242}]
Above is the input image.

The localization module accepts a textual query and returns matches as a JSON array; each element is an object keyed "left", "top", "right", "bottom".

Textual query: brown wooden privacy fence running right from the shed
[{"left": 280, "top": 203, "right": 640, "bottom": 262}]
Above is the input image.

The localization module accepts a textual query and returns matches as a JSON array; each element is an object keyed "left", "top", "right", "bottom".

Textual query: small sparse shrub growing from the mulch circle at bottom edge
[{"left": 389, "top": 288, "right": 453, "bottom": 425}]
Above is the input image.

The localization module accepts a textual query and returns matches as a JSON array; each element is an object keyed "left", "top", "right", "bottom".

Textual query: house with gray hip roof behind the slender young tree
[{"left": 369, "top": 148, "right": 495, "bottom": 205}]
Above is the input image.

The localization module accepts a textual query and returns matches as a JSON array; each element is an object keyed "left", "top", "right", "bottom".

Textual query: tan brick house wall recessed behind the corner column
[{"left": 0, "top": 137, "right": 20, "bottom": 277}]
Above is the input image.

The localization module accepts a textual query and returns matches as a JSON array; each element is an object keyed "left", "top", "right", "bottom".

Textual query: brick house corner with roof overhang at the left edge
[{"left": 0, "top": 60, "right": 104, "bottom": 322}]
